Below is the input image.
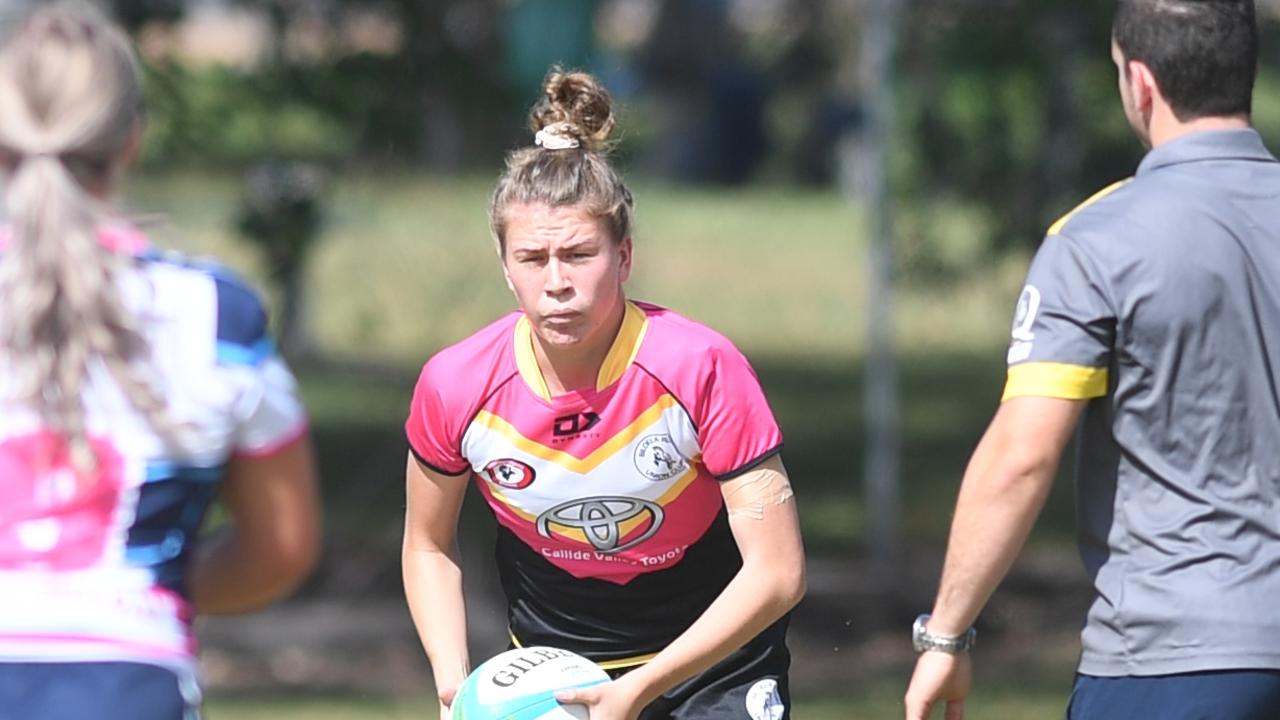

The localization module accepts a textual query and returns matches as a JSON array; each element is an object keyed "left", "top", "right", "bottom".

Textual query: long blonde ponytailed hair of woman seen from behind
[{"left": 0, "top": 3, "right": 172, "bottom": 471}]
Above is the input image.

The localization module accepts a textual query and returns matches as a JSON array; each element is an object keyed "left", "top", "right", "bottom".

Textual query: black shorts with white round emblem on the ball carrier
[{"left": 612, "top": 618, "right": 791, "bottom": 720}]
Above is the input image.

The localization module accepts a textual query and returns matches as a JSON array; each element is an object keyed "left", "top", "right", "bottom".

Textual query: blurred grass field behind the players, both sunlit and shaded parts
[{"left": 129, "top": 174, "right": 1075, "bottom": 720}]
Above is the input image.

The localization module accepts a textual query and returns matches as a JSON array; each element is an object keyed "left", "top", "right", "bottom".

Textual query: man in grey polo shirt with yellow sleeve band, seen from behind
[{"left": 906, "top": 0, "right": 1280, "bottom": 720}]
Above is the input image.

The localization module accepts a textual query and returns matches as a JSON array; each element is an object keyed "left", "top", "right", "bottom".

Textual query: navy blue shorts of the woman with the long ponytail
[{"left": 0, "top": 662, "right": 200, "bottom": 720}]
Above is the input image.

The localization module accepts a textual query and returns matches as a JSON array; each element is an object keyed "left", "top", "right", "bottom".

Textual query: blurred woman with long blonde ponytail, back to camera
[{"left": 0, "top": 3, "right": 319, "bottom": 720}]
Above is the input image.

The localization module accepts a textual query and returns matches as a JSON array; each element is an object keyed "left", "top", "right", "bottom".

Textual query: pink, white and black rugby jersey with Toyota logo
[{"left": 406, "top": 302, "right": 782, "bottom": 659}]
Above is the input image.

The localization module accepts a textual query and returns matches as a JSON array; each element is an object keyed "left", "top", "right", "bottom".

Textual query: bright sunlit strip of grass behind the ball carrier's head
[{"left": 120, "top": 166, "right": 1025, "bottom": 364}]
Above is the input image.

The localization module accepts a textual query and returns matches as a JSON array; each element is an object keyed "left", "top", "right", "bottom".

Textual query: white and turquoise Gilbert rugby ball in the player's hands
[{"left": 449, "top": 647, "right": 609, "bottom": 720}]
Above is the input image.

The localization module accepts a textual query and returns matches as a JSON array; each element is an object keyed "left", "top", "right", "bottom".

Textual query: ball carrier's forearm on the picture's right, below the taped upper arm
[{"left": 618, "top": 527, "right": 805, "bottom": 707}]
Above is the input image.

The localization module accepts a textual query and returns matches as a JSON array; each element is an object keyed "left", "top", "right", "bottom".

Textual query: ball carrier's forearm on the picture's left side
[{"left": 402, "top": 544, "right": 470, "bottom": 689}]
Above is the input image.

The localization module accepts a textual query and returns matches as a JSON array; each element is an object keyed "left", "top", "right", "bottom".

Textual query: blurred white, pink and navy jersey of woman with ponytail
[{"left": 0, "top": 227, "right": 306, "bottom": 667}]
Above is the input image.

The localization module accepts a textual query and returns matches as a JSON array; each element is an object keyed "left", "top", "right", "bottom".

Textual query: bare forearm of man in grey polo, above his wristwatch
[{"left": 929, "top": 422, "right": 1057, "bottom": 635}]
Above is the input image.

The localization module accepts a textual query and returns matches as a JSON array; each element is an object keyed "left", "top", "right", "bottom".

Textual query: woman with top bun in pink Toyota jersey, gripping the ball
[{"left": 403, "top": 69, "right": 804, "bottom": 720}]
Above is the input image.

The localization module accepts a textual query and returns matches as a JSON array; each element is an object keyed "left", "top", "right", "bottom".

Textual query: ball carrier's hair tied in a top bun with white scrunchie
[{"left": 489, "top": 68, "right": 635, "bottom": 252}]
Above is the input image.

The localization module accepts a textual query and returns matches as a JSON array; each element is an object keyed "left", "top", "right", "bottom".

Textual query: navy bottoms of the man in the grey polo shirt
[{"left": 1066, "top": 670, "right": 1280, "bottom": 720}]
